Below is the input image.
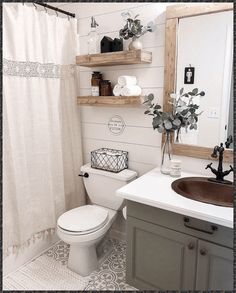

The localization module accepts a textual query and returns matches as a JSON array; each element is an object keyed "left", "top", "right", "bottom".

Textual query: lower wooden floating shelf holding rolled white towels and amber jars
[{"left": 77, "top": 96, "right": 143, "bottom": 106}]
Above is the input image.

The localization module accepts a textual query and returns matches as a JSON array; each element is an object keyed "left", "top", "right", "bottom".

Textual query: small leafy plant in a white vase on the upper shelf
[{"left": 119, "top": 12, "right": 155, "bottom": 50}]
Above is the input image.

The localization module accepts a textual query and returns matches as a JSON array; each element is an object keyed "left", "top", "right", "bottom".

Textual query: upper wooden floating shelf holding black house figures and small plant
[{"left": 76, "top": 50, "right": 152, "bottom": 67}]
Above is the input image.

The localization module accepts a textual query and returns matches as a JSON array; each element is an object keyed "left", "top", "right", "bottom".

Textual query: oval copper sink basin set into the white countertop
[{"left": 171, "top": 177, "right": 233, "bottom": 207}]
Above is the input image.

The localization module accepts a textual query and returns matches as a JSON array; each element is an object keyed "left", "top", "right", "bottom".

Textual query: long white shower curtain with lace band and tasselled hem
[{"left": 3, "top": 3, "right": 85, "bottom": 254}]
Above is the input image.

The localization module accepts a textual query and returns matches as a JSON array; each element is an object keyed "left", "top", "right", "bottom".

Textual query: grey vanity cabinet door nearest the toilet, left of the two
[{"left": 126, "top": 217, "right": 197, "bottom": 290}]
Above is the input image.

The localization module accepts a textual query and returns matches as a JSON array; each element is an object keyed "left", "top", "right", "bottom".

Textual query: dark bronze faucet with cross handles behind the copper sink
[{"left": 205, "top": 143, "right": 234, "bottom": 184}]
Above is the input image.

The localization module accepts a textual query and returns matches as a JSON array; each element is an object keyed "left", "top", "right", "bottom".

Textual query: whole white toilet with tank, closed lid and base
[{"left": 57, "top": 164, "right": 137, "bottom": 276}]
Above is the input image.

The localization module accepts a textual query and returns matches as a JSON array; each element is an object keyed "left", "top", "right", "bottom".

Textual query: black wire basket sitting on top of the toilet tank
[{"left": 91, "top": 148, "right": 128, "bottom": 173}]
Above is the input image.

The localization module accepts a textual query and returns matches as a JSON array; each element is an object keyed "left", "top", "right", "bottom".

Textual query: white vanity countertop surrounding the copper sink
[{"left": 116, "top": 168, "right": 233, "bottom": 228}]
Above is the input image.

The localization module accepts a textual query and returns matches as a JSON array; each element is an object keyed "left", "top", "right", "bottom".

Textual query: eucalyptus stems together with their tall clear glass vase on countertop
[{"left": 144, "top": 88, "right": 205, "bottom": 174}]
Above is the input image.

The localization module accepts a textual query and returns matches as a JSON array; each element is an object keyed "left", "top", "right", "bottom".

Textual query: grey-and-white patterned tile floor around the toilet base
[{"left": 46, "top": 238, "right": 137, "bottom": 291}]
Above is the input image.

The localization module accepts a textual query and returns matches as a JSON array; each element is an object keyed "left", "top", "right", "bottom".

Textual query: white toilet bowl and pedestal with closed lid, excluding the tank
[{"left": 57, "top": 205, "right": 117, "bottom": 276}]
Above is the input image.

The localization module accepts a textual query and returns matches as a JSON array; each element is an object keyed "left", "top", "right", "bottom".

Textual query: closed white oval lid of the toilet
[{"left": 57, "top": 205, "right": 108, "bottom": 233}]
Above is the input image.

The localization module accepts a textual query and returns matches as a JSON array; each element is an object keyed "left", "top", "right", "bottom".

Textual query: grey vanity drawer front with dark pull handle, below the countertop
[{"left": 127, "top": 201, "right": 233, "bottom": 248}]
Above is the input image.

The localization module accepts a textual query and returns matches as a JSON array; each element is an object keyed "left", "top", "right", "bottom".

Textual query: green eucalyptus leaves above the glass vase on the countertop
[{"left": 144, "top": 88, "right": 205, "bottom": 137}]
